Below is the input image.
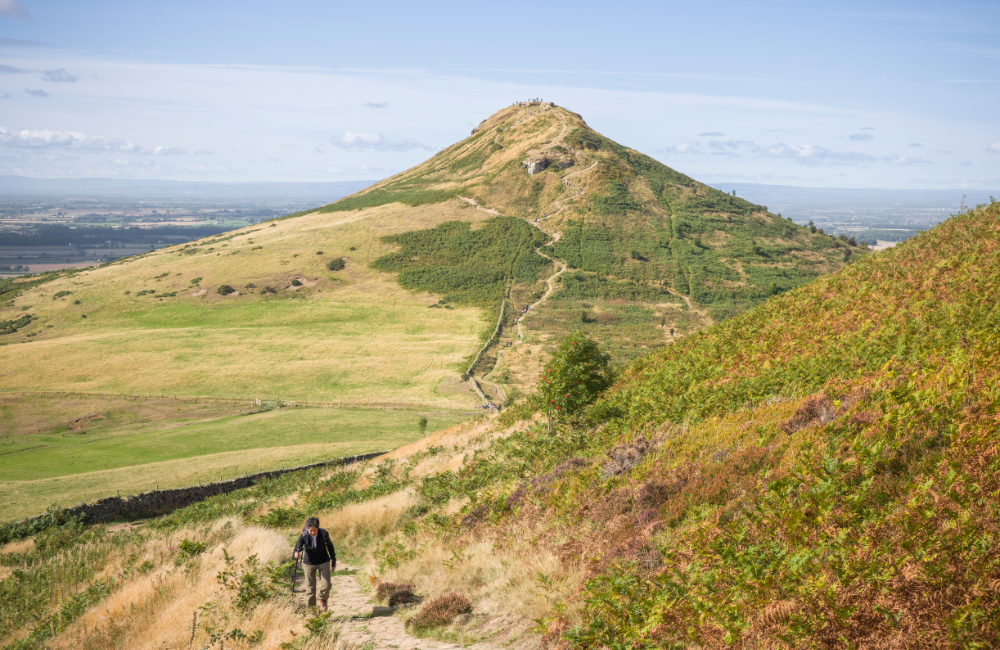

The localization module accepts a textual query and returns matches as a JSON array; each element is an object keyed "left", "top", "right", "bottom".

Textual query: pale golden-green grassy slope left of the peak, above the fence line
[{"left": 0, "top": 205, "right": 486, "bottom": 405}]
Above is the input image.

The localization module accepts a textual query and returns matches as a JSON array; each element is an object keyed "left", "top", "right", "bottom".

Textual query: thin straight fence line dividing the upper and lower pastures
[{"left": 0, "top": 390, "right": 480, "bottom": 415}]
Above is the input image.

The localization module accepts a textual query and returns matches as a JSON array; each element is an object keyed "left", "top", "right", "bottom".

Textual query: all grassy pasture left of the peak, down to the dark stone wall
[{"left": 0, "top": 203, "right": 500, "bottom": 508}]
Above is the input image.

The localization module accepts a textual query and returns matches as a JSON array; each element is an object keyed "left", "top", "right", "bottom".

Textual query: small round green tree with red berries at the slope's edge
[{"left": 541, "top": 332, "right": 611, "bottom": 413}]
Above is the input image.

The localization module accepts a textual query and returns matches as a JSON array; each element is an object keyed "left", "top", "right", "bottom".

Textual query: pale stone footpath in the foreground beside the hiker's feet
[{"left": 295, "top": 562, "right": 524, "bottom": 650}]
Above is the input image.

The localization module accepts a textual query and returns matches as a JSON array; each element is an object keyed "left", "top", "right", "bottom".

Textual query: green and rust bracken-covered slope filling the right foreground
[{"left": 414, "top": 203, "right": 1000, "bottom": 648}]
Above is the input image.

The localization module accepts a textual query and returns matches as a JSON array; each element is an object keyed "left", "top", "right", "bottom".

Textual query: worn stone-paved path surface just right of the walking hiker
[{"left": 295, "top": 562, "right": 509, "bottom": 650}]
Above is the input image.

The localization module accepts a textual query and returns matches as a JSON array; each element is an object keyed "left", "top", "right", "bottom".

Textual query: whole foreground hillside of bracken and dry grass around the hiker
[{"left": 0, "top": 204, "right": 1000, "bottom": 648}]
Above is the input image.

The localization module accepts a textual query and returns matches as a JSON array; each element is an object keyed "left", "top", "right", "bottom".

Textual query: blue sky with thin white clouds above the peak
[{"left": 0, "top": 0, "right": 1000, "bottom": 190}]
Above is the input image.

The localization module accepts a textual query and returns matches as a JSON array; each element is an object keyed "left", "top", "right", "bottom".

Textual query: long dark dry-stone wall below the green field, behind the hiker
[{"left": 18, "top": 451, "right": 389, "bottom": 523}]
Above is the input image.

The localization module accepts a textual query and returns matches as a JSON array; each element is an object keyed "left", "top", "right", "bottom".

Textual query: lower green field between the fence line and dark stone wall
[{"left": 0, "top": 400, "right": 469, "bottom": 520}]
